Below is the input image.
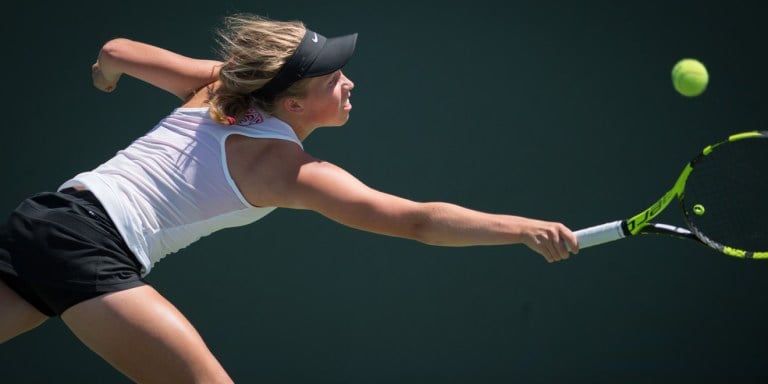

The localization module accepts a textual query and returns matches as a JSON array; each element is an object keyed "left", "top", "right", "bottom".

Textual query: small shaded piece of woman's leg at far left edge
[{"left": 0, "top": 280, "right": 48, "bottom": 344}]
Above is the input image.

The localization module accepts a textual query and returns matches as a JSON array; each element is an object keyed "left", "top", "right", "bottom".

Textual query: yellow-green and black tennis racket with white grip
[{"left": 575, "top": 131, "right": 768, "bottom": 259}]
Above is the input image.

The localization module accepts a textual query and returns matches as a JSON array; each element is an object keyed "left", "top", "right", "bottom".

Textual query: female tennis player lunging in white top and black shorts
[{"left": 0, "top": 14, "right": 578, "bottom": 383}]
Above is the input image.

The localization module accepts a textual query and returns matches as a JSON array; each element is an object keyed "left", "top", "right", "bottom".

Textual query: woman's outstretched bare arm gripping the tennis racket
[{"left": 243, "top": 143, "right": 578, "bottom": 262}]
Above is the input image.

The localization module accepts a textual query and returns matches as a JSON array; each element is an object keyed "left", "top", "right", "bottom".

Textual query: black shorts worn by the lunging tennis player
[{"left": 0, "top": 189, "right": 146, "bottom": 316}]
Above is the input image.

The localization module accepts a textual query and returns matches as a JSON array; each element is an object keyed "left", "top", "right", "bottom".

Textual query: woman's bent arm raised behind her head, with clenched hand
[{"left": 91, "top": 38, "right": 222, "bottom": 100}]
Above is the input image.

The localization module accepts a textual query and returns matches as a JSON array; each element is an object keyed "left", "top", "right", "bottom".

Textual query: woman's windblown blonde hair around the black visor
[{"left": 210, "top": 14, "right": 307, "bottom": 124}]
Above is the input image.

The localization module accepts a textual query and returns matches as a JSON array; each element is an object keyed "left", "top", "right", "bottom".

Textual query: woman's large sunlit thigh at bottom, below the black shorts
[{"left": 61, "top": 285, "right": 232, "bottom": 383}]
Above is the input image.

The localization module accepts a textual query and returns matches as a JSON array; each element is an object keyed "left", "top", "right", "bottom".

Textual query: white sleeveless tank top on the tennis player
[{"left": 59, "top": 108, "right": 301, "bottom": 275}]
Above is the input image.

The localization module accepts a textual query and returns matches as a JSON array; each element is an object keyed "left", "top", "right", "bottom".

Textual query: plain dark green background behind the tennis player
[{"left": 0, "top": 0, "right": 768, "bottom": 383}]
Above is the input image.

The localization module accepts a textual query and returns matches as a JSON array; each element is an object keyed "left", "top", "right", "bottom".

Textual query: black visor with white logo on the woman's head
[{"left": 253, "top": 30, "right": 357, "bottom": 100}]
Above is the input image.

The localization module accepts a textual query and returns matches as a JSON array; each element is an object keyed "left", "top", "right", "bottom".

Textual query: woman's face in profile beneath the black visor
[{"left": 304, "top": 70, "right": 355, "bottom": 127}]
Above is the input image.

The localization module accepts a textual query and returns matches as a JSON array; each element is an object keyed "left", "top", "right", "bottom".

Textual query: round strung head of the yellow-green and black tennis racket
[{"left": 679, "top": 131, "right": 768, "bottom": 259}]
